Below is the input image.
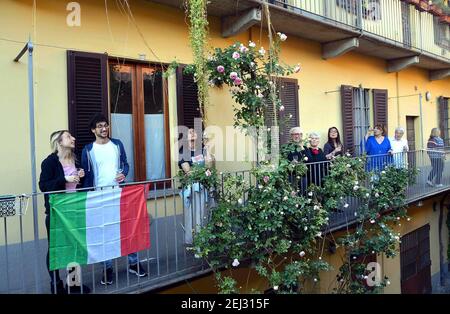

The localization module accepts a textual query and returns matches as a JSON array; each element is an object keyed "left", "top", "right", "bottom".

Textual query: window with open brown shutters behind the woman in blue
[{"left": 341, "top": 85, "right": 388, "bottom": 155}]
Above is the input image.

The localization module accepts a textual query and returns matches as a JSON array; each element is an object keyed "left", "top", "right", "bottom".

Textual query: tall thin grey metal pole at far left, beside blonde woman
[{"left": 14, "top": 40, "right": 40, "bottom": 293}]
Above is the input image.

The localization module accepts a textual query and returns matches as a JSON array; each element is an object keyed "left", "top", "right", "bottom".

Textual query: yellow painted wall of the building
[{"left": 0, "top": 0, "right": 450, "bottom": 250}]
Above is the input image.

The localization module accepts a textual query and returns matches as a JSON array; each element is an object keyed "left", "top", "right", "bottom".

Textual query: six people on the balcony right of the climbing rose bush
[{"left": 284, "top": 124, "right": 445, "bottom": 191}]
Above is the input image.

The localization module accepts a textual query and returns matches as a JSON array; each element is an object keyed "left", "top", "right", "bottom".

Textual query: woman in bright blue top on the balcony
[{"left": 365, "top": 124, "right": 392, "bottom": 171}]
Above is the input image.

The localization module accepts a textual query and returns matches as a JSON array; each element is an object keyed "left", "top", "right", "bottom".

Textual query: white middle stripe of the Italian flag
[{"left": 86, "top": 188, "right": 122, "bottom": 264}]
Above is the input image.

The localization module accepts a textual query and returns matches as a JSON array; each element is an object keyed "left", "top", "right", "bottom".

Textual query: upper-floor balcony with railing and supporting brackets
[{"left": 149, "top": 0, "right": 450, "bottom": 80}]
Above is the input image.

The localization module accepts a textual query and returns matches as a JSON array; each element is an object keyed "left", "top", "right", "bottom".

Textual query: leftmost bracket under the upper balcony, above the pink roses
[{"left": 222, "top": 8, "right": 261, "bottom": 37}]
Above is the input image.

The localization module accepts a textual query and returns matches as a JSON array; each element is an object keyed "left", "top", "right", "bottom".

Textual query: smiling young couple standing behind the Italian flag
[{"left": 39, "top": 114, "right": 147, "bottom": 294}]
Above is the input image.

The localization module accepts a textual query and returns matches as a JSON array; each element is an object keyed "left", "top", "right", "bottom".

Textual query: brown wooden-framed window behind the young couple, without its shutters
[{"left": 109, "top": 61, "right": 170, "bottom": 181}]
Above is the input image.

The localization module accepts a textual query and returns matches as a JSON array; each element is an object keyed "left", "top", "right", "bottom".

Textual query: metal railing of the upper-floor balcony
[{"left": 270, "top": 0, "right": 450, "bottom": 59}]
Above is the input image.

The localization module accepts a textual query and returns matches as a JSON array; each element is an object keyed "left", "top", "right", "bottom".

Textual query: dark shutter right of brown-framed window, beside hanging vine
[{"left": 177, "top": 67, "right": 201, "bottom": 128}]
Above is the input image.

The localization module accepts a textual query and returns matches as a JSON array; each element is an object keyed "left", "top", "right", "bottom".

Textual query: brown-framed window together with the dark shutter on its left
[{"left": 68, "top": 51, "right": 171, "bottom": 187}]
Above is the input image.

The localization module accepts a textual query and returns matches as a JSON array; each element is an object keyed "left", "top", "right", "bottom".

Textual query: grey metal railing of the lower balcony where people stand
[{"left": 0, "top": 150, "right": 450, "bottom": 293}]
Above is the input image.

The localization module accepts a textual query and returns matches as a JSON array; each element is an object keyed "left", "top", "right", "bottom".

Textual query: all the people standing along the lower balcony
[{"left": 39, "top": 114, "right": 445, "bottom": 293}]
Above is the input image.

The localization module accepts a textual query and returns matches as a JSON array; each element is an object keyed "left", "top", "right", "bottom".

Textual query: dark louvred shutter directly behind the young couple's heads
[{"left": 67, "top": 50, "right": 108, "bottom": 160}]
